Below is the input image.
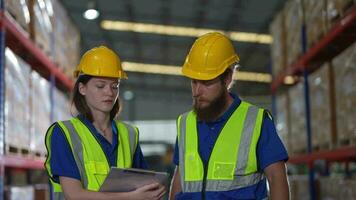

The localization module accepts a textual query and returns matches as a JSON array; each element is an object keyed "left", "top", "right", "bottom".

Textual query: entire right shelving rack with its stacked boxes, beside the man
[{"left": 270, "top": 0, "right": 356, "bottom": 200}]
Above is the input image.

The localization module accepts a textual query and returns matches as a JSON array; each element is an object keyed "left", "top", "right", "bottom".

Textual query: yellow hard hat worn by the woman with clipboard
[{"left": 73, "top": 46, "right": 127, "bottom": 79}]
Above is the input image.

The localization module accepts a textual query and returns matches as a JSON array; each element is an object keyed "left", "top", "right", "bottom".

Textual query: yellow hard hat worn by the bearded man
[{"left": 182, "top": 32, "right": 240, "bottom": 80}]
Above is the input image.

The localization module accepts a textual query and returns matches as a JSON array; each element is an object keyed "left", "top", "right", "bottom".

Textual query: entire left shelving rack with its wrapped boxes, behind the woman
[{"left": 0, "top": 0, "right": 79, "bottom": 199}]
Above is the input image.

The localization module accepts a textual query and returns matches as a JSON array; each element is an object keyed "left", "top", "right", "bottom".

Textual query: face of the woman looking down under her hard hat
[{"left": 79, "top": 77, "right": 120, "bottom": 113}]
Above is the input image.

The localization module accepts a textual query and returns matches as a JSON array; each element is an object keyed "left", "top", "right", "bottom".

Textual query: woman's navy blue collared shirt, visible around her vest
[{"left": 50, "top": 116, "right": 147, "bottom": 183}]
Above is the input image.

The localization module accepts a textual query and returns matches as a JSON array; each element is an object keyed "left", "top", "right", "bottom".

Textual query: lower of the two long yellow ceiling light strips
[{"left": 122, "top": 62, "right": 272, "bottom": 83}]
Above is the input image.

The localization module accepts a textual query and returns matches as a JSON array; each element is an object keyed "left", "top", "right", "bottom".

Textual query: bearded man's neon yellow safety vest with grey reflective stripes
[{"left": 177, "top": 101, "right": 265, "bottom": 195}]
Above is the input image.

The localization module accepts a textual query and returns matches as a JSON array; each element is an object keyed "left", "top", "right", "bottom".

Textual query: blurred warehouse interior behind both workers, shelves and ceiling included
[{"left": 0, "top": 0, "right": 356, "bottom": 200}]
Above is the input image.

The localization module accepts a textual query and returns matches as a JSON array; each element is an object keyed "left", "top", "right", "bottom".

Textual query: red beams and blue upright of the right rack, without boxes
[{"left": 271, "top": 5, "right": 356, "bottom": 200}]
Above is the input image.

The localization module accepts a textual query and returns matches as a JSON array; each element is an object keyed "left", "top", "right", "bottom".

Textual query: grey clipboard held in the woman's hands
[{"left": 99, "top": 167, "right": 168, "bottom": 192}]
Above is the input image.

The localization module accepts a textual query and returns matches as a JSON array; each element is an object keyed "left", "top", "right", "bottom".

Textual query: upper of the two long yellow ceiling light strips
[{"left": 101, "top": 20, "right": 272, "bottom": 44}]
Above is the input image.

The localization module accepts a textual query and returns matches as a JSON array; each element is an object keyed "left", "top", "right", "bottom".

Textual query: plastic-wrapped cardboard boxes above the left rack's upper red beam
[{"left": 6, "top": 0, "right": 80, "bottom": 80}]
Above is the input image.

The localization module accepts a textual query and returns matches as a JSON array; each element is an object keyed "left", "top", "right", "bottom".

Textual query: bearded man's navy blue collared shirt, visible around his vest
[{"left": 173, "top": 94, "right": 288, "bottom": 200}]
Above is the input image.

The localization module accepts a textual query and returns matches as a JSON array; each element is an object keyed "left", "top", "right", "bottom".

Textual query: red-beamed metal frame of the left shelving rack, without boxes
[{"left": 0, "top": 0, "right": 74, "bottom": 199}]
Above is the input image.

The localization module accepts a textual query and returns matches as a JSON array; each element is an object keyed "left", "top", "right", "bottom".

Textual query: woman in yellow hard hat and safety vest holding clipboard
[{"left": 45, "top": 46, "right": 165, "bottom": 200}]
